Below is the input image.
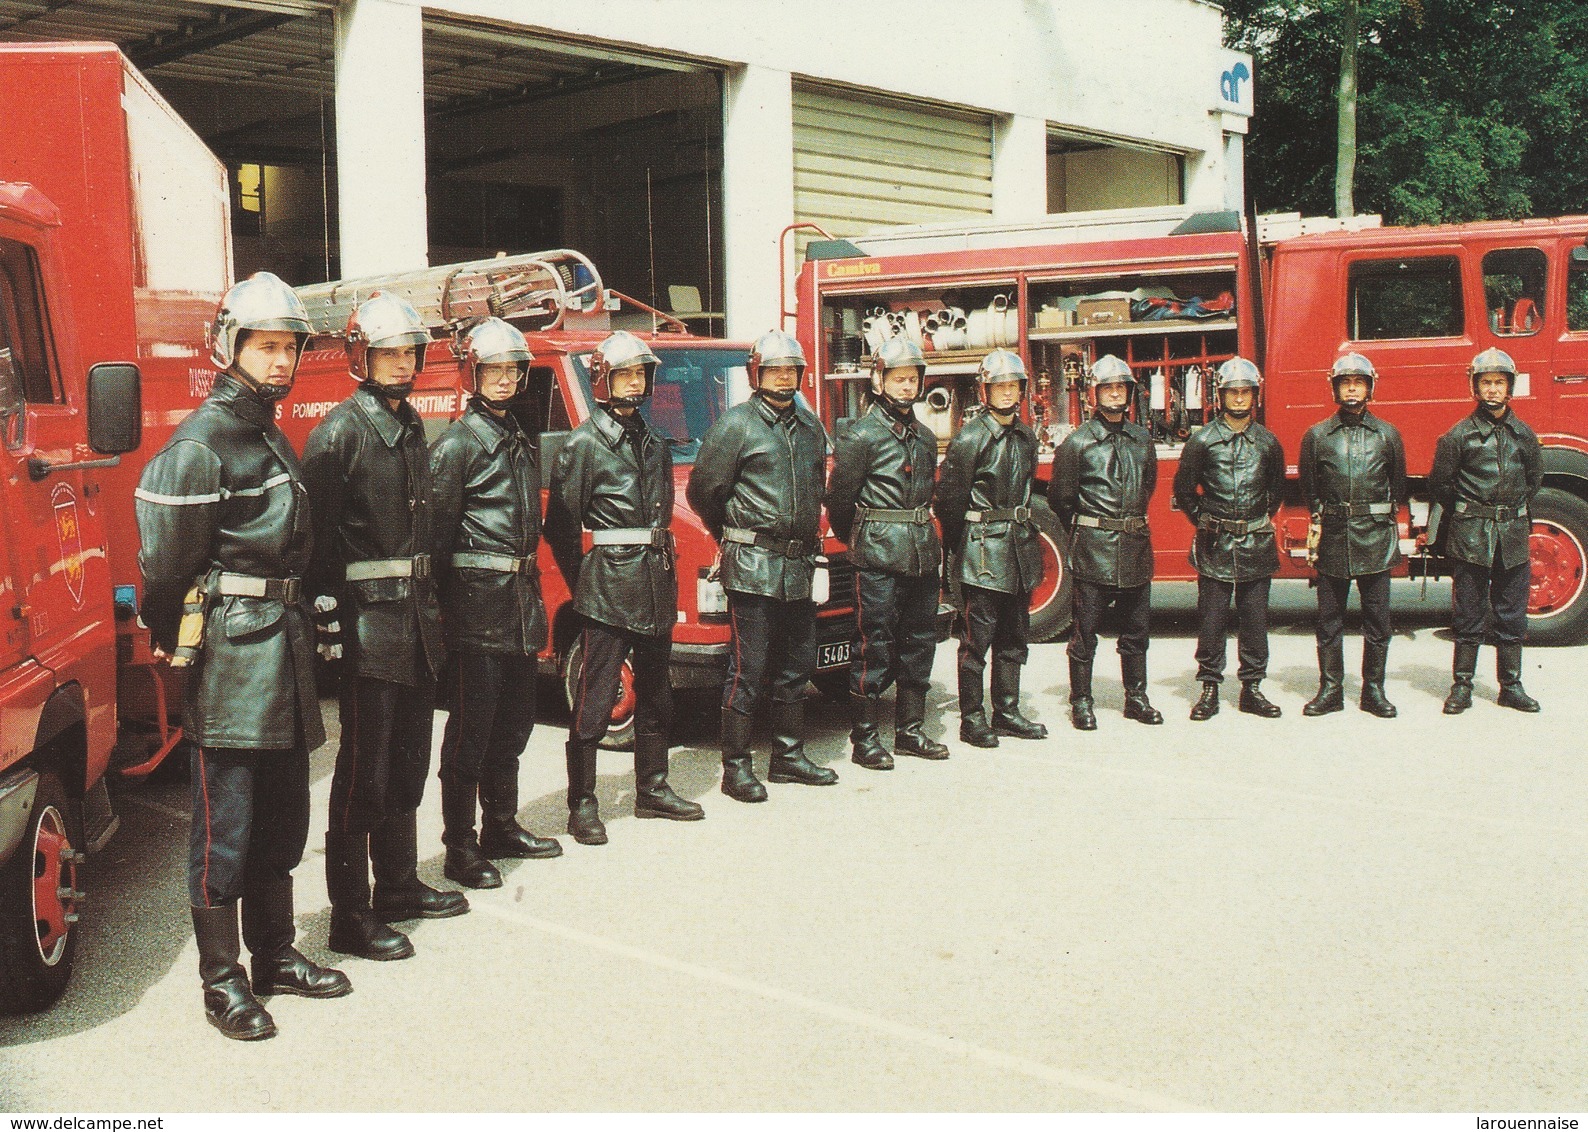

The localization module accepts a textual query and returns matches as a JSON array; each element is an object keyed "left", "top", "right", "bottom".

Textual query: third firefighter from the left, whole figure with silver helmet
[{"left": 430, "top": 318, "right": 562, "bottom": 889}]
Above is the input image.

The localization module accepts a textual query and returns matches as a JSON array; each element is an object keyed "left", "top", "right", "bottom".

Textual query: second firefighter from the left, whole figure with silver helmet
[{"left": 303, "top": 294, "right": 468, "bottom": 959}]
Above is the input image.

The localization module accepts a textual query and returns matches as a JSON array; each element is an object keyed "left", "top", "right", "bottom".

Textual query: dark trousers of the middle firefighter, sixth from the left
[{"left": 850, "top": 570, "right": 940, "bottom": 699}]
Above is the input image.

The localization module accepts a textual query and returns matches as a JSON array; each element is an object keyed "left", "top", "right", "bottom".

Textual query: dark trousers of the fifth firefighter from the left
[{"left": 723, "top": 589, "right": 816, "bottom": 716}]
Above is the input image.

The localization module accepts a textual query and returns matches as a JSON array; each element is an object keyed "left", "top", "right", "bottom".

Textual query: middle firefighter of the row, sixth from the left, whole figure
[{"left": 827, "top": 335, "right": 948, "bottom": 770}]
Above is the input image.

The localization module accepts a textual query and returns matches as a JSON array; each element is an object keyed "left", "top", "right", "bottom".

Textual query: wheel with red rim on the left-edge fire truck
[{"left": 0, "top": 770, "right": 83, "bottom": 1015}]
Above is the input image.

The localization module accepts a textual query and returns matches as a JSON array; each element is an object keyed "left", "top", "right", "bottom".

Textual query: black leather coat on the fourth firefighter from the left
[{"left": 546, "top": 408, "right": 678, "bottom": 637}]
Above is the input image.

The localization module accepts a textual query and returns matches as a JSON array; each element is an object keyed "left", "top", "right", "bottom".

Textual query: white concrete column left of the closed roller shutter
[{"left": 723, "top": 67, "right": 797, "bottom": 338}]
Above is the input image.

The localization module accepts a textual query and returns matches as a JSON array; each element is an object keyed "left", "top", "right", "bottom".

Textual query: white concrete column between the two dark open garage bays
[{"left": 335, "top": 0, "right": 430, "bottom": 278}]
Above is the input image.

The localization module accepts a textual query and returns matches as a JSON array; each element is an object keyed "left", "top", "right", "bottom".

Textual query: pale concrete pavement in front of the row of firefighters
[{"left": 0, "top": 583, "right": 1588, "bottom": 1113}]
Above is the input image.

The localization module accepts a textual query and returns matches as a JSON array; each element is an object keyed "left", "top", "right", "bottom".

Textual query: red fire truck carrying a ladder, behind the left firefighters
[{"left": 279, "top": 257, "right": 850, "bottom": 748}]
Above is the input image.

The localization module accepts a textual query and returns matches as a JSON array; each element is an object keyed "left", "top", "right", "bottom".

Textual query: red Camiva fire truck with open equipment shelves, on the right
[{"left": 797, "top": 208, "right": 1588, "bottom": 643}]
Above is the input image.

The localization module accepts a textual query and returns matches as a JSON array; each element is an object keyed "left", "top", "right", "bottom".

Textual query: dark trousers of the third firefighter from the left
[{"left": 440, "top": 651, "right": 537, "bottom": 792}]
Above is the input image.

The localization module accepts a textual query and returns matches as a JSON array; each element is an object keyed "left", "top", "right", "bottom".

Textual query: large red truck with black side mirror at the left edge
[{"left": 0, "top": 43, "right": 214, "bottom": 1013}]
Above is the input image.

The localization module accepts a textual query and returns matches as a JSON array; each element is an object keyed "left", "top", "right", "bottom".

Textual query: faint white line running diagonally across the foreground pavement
[{"left": 470, "top": 894, "right": 1205, "bottom": 1113}]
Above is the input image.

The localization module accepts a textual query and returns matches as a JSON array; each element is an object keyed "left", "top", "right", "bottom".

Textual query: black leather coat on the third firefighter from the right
[{"left": 1175, "top": 416, "right": 1285, "bottom": 581}]
